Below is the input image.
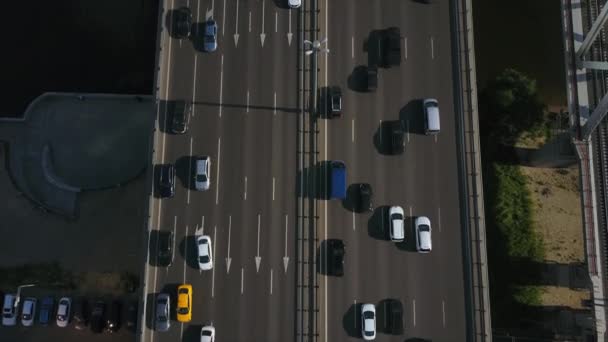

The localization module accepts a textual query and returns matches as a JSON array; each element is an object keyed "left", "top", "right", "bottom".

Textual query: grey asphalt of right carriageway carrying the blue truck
[{"left": 319, "top": 0, "right": 466, "bottom": 341}]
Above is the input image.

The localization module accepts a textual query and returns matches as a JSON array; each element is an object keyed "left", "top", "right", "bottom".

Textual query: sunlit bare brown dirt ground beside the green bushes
[{"left": 521, "top": 165, "right": 590, "bottom": 309}]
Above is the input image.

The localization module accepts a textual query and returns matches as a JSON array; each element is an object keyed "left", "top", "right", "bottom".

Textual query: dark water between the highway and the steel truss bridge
[{"left": 473, "top": 0, "right": 567, "bottom": 106}]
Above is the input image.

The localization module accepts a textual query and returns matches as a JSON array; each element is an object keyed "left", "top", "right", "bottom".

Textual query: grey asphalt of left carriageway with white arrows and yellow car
[{"left": 144, "top": 0, "right": 298, "bottom": 341}]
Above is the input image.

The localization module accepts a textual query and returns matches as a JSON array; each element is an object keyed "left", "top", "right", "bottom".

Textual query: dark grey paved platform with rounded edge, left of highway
[{"left": 0, "top": 93, "right": 155, "bottom": 217}]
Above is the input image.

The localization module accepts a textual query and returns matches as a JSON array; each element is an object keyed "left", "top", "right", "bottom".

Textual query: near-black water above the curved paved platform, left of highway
[{"left": 0, "top": 0, "right": 159, "bottom": 116}]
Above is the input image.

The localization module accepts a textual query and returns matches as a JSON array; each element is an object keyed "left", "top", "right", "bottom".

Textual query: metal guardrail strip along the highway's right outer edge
[{"left": 451, "top": 0, "right": 492, "bottom": 342}]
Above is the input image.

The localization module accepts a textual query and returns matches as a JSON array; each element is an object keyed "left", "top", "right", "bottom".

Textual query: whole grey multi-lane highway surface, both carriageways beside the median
[{"left": 143, "top": 0, "right": 467, "bottom": 341}]
